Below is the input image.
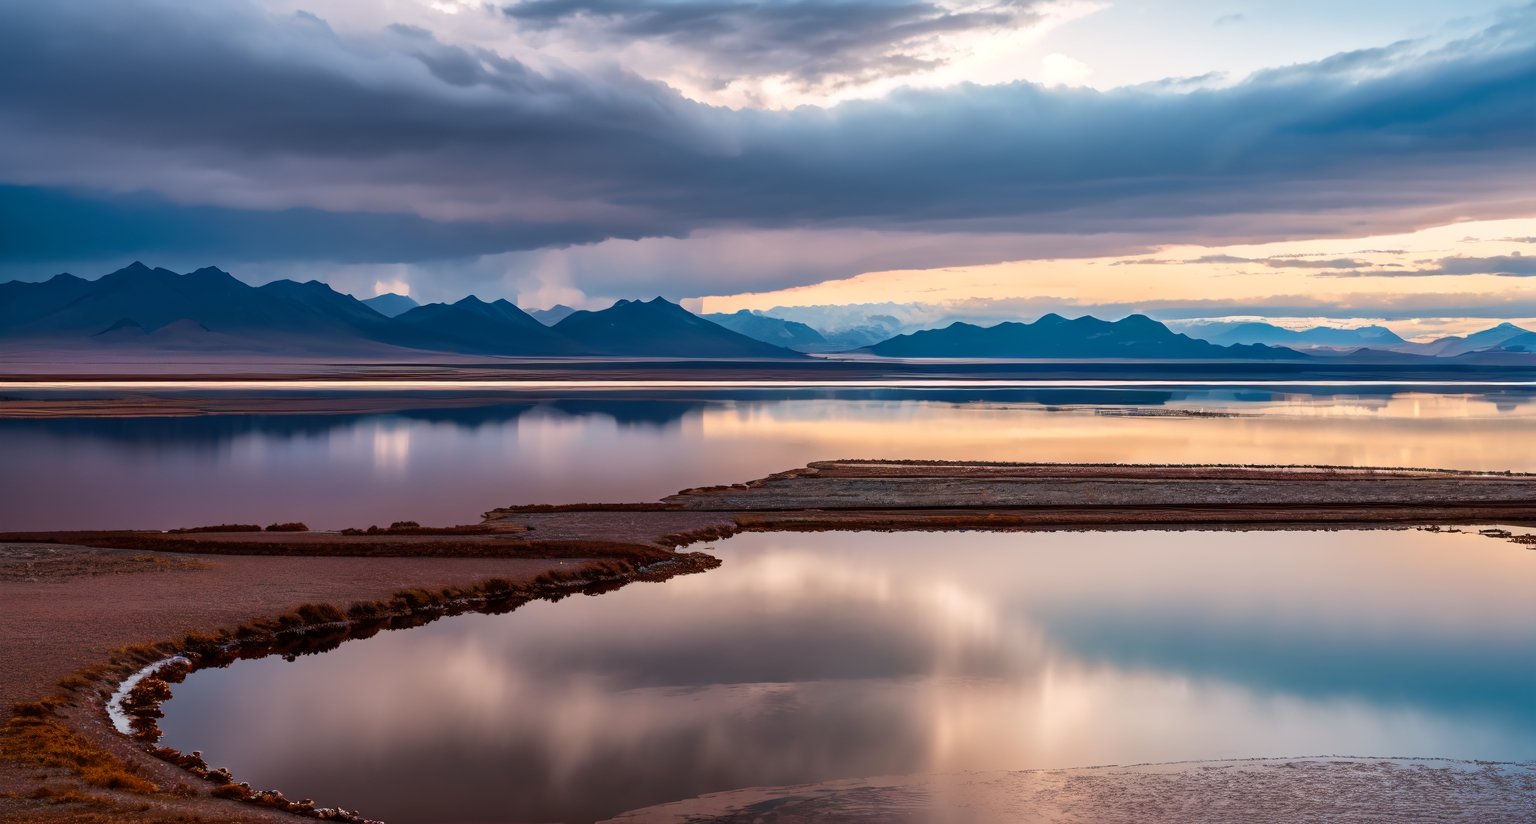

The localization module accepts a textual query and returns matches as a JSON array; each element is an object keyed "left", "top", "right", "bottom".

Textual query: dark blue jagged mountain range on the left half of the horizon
[{"left": 0, "top": 263, "right": 803, "bottom": 358}]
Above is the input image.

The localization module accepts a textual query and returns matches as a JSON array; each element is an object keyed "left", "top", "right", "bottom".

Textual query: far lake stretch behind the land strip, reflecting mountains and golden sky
[{"left": 9, "top": 386, "right": 1536, "bottom": 530}]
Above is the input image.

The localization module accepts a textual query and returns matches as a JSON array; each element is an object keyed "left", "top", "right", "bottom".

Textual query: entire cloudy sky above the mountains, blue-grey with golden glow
[{"left": 0, "top": 0, "right": 1536, "bottom": 335}]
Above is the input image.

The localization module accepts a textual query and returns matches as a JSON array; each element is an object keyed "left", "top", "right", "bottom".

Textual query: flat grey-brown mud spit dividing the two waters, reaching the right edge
[{"left": 484, "top": 461, "right": 1536, "bottom": 543}]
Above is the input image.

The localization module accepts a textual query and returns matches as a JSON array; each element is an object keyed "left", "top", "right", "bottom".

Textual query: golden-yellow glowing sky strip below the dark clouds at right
[{"left": 697, "top": 218, "right": 1536, "bottom": 340}]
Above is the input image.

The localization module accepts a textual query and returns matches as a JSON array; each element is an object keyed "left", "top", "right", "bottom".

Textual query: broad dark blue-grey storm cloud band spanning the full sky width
[{"left": 0, "top": 0, "right": 1536, "bottom": 279}]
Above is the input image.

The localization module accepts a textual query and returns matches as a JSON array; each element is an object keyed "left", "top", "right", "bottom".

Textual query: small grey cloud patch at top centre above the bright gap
[{"left": 502, "top": 0, "right": 1037, "bottom": 88}]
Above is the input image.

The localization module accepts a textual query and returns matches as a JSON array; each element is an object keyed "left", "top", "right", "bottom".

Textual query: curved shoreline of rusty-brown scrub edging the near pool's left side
[{"left": 0, "top": 547, "right": 720, "bottom": 824}]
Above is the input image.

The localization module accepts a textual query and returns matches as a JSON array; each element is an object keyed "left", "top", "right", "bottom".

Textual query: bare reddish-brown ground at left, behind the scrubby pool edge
[{"left": 0, "top": 544, "right": 623, "bottom": 821}]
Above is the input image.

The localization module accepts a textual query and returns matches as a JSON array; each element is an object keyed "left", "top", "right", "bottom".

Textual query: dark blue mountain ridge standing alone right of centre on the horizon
[{"left": 866, "top": 314, "right": 1306, "bottom": 360}]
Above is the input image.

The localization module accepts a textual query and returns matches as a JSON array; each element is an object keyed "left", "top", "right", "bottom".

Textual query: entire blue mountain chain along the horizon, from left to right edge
[{"left": 0, "top": 263, "right": 1536, "bottom": 364}]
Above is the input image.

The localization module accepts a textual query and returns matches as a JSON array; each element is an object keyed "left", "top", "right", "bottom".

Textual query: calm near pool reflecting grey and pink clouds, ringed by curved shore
[{"left": 152, "top": 530, "right": 1536, "bottom": 824}]
